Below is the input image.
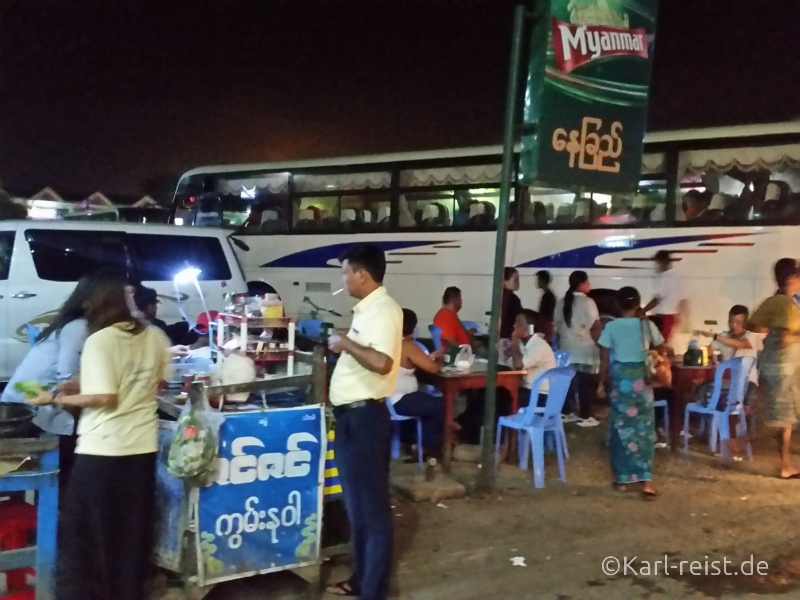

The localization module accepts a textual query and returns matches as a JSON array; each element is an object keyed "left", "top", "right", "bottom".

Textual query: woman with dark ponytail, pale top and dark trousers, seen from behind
[{"left": 555, "top": 271, "right": 602, "bottom": 427}]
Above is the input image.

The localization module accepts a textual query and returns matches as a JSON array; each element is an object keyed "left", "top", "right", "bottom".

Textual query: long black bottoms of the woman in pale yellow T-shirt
[{"left": 56, "top": 453, "right": 156, "bottom": 600}]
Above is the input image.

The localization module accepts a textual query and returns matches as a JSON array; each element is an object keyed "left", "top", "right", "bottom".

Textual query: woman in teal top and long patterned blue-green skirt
[{"left": 598, "top": 287, "right": 664, "bottom": 500}]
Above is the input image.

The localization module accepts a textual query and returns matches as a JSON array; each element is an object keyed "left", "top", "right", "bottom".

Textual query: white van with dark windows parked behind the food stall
[{"left": 0, "top": 221, "right": 247, "bottom": 381}]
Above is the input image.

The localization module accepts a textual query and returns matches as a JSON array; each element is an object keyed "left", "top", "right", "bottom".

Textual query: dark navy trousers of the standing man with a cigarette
[{"left": 334, "top": 401, "right": 393, "bottom": 600}]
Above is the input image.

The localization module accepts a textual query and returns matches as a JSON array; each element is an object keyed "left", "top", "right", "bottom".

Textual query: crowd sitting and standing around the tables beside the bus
[{"left": 382, "top": 250, "right": 800, "bottom": 498}]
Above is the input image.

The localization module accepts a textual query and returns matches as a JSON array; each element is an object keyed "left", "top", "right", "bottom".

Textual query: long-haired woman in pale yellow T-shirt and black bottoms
[{"left": 29, "top": 273, "right": 171, "bottom": 600}]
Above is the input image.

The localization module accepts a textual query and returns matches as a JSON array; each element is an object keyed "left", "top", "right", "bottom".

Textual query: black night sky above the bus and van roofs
[{"left": 0, "top": 0, "right": 800, "bottom": 194}]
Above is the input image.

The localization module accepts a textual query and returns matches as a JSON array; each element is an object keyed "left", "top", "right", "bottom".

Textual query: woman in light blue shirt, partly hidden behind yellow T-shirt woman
[{"left": 0, "top": 275, "right": 104, "bottom": 486}]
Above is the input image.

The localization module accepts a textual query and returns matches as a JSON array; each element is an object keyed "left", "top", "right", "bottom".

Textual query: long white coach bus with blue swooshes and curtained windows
[{"left": 171, "top": 122, "right": 800, "bottom": 346}]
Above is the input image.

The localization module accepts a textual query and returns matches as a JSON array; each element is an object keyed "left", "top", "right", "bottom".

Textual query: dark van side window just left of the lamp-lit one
[{"left": 25, "top": 229, "right": 130, "bottom": 281}]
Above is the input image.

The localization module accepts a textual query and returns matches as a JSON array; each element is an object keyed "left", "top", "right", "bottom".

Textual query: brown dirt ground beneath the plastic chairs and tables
[{"left": 175, "top": 418, "right": 800, "bottom": 600}]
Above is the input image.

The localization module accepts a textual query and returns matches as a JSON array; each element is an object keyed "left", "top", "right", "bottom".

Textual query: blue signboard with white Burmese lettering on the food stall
[{"left": 198, "top": 406, "right": 325, "bottom": 583}]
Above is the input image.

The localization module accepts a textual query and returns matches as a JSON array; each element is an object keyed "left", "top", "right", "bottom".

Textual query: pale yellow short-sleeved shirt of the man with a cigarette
[{"left": 330, "top": 286, "right": 403, "bottom": 406}]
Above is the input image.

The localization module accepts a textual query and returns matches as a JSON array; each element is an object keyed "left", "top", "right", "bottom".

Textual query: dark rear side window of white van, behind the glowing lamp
[{"left": 128, "top": 233, "right": 231, "bottom": 281}]
